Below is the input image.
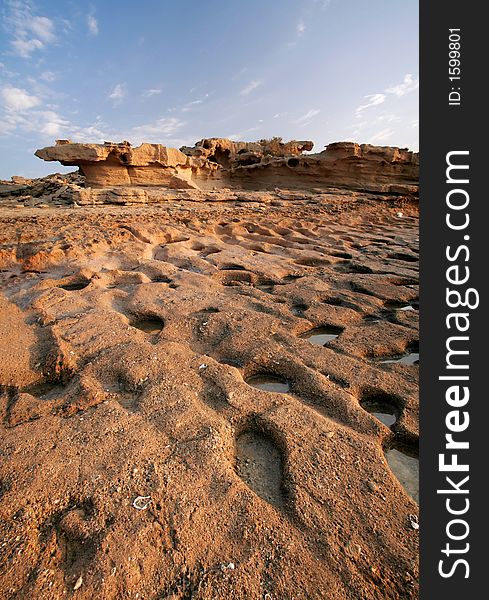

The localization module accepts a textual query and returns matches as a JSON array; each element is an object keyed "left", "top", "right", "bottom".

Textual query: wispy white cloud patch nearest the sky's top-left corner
[{"left": 4, "top": 0, "right": 56, "bottom": 58}]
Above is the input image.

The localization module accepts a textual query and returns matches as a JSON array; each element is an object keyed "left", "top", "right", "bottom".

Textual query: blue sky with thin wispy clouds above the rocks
[{"left": 0, "top": 0, "right": 418, "bottom": 179}]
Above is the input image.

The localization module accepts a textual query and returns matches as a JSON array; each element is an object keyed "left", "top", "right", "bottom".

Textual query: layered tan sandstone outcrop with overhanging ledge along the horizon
[{"left": 36, "top": 138, "right": 419, "bottom": 195}]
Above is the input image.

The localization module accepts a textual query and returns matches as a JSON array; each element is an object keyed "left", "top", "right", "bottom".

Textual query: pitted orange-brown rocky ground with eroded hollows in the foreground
[{"left": 0, "top": 195, "right": 419, "bottom": 600}]
